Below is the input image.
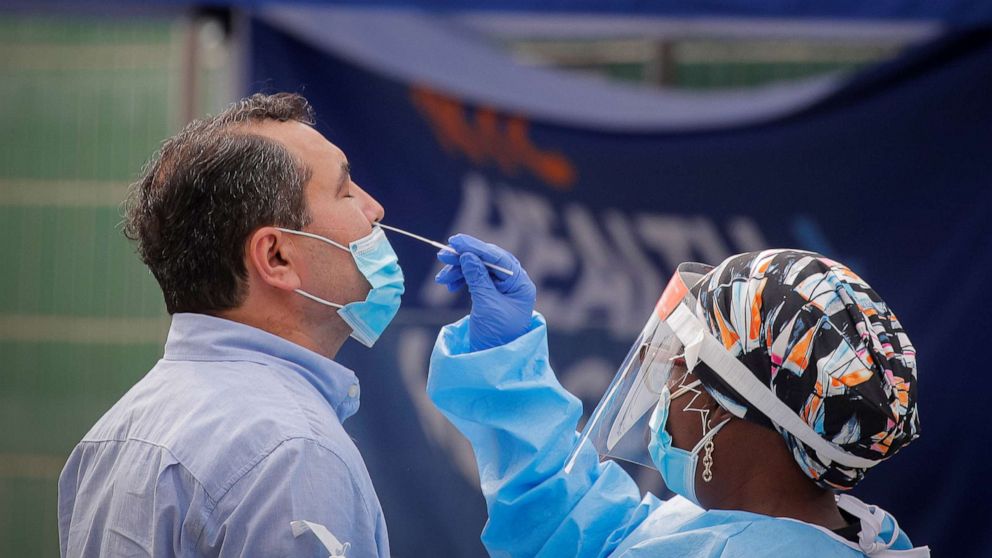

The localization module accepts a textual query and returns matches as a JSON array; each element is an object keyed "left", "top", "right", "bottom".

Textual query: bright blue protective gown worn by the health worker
[{"left": 427, "top": 313, "right": 928, "bottom": 557}]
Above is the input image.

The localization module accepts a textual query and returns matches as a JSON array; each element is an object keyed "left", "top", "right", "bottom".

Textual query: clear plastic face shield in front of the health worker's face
[{"left": 565, "top": 263, "right": 712, "bottom": 472}]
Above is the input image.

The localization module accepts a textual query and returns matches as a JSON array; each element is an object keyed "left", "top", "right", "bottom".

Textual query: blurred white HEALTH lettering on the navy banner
[{"left": 420, "top": 173, "right": 767, "bottom": 339}]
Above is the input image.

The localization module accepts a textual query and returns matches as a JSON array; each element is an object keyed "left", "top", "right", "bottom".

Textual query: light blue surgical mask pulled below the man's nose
[{"left": 279, "top": 227, "right": 404, "bottom": 347}]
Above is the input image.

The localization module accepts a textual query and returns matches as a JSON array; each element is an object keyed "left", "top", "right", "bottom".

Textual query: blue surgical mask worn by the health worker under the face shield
[{"left": 648, "top": 386, "right": 730, "bottom": 507}]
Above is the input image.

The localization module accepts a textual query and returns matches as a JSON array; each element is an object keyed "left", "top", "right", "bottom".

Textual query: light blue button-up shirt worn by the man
[{"left": 59, "top": 314, "right": 389, "bottom": 558}]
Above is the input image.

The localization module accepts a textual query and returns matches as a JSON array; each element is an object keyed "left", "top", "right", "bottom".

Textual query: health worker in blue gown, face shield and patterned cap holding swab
[{"left": 428, "top": 241, "right": 929, "bottom": 558}]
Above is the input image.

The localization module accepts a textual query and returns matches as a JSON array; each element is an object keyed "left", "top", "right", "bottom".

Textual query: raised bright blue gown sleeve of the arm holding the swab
[{"left": 427, "top": 312, "right": 661, "bottom": 557}]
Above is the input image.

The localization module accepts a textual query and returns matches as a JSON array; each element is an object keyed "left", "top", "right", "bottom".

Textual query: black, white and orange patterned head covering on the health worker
[{"left": 690, "top": 250, "right": 920, "bottom": 490}]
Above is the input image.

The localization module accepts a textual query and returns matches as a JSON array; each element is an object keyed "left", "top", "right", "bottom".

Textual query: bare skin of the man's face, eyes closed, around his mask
[{"left": 252, "top": 121, "right": 385, "bottom": 308}]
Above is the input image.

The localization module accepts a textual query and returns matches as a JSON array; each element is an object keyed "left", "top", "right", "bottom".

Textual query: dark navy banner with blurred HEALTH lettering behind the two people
[{"left": 249, "top": 20, "right": 992, "bottom": 556}]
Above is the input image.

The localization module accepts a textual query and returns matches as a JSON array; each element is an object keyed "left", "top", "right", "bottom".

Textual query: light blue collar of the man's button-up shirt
[{"left": 163, "top": 313, "right": 361, "bottom": 422}]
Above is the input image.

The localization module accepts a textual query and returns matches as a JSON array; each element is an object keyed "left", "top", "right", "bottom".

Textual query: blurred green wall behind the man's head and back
[{"left": 0, "top": 11, "right": 232, "bottom": 556}]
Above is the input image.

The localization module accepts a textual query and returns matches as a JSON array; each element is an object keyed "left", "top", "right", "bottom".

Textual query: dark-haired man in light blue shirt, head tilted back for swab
[{"left": 59, "top": 94, "right": 403, "bottom": 558}]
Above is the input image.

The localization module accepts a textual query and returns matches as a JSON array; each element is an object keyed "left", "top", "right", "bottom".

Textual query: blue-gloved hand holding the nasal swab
[{"left": 434, "top": 234, "right": 537, "bottom": 351}]
